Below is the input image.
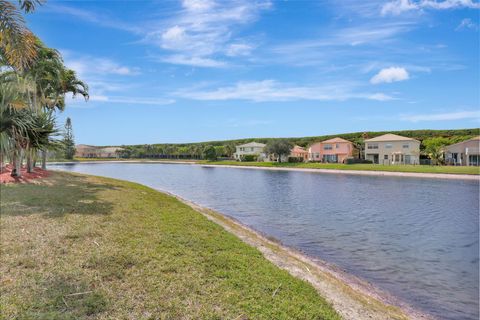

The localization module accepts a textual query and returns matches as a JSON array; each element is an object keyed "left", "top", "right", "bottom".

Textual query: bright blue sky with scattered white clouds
[{"left": 27, "top": 0, "right": 480, "bottom": 145}]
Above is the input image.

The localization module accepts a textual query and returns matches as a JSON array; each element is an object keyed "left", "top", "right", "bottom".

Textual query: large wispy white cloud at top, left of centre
[{"left": 144, "top": 0, "right": 270, "bottom": 67}]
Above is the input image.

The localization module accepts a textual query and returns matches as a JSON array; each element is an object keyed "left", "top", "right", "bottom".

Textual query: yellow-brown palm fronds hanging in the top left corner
[{"left": 0, "top": 0, "right": 43, "bottom": 70}]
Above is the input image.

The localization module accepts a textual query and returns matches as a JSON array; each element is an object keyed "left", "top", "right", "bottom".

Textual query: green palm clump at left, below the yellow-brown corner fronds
[{"left": 0, "top": 42, "right": 88, "bottom": 175}]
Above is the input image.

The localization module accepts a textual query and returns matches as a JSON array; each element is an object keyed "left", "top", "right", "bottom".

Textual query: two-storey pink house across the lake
[{"left": 308, "top": 138, "right": 356, "bottom": 163}]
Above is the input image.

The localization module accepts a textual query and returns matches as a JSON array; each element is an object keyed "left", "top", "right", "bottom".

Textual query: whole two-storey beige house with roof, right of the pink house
[{"left": 365, "top": 133, "right": 420, "bottom": 165}]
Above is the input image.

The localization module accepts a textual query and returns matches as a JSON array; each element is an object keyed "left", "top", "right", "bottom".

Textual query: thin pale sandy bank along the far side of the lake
[{"left": 48, "top": 160, "right": 480, "bottom": 181}]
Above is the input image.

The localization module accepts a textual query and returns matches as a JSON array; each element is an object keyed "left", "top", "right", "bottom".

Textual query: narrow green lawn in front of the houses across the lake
[{"left": 199, "top": 161, "right": 480, "bottom": 174}]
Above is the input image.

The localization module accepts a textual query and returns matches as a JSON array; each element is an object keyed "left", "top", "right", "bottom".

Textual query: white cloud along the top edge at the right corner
[{"left": 381, "top": 0, "right": 480, "bottom": 15}]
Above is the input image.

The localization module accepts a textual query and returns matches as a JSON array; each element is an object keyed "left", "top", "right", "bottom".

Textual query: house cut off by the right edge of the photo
[{"left": 444, "top": 136, "right": 480, "bottom": 166}]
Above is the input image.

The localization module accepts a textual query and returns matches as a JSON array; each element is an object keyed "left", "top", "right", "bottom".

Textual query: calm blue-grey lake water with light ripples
[{"left": 52, "top": 163, "right": 479, "bottom": 319}]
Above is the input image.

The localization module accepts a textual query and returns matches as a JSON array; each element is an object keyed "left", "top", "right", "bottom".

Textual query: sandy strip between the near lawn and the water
[{"left": 162, "top": 189, "right": 435, "bottom": 320}]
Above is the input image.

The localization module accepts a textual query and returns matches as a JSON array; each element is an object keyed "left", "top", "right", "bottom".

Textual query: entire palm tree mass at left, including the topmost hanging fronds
[{"left": 0, "top": 0, "right": 88, "bottom": 176}]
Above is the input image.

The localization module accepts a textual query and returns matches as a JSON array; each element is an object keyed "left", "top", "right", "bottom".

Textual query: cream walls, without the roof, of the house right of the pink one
[{"left": 365, "top": 140, "right": 420, "bottom": 164}]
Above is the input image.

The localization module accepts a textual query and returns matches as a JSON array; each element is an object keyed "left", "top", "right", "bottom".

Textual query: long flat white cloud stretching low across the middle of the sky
[{"left": 175, "top": 80, "right": 393, "bottom": 102}]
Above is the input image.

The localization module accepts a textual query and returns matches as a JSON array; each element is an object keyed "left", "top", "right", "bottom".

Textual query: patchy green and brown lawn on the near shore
[{"left": 0, "top": 172, "right": 339, "bottom": 319}]
